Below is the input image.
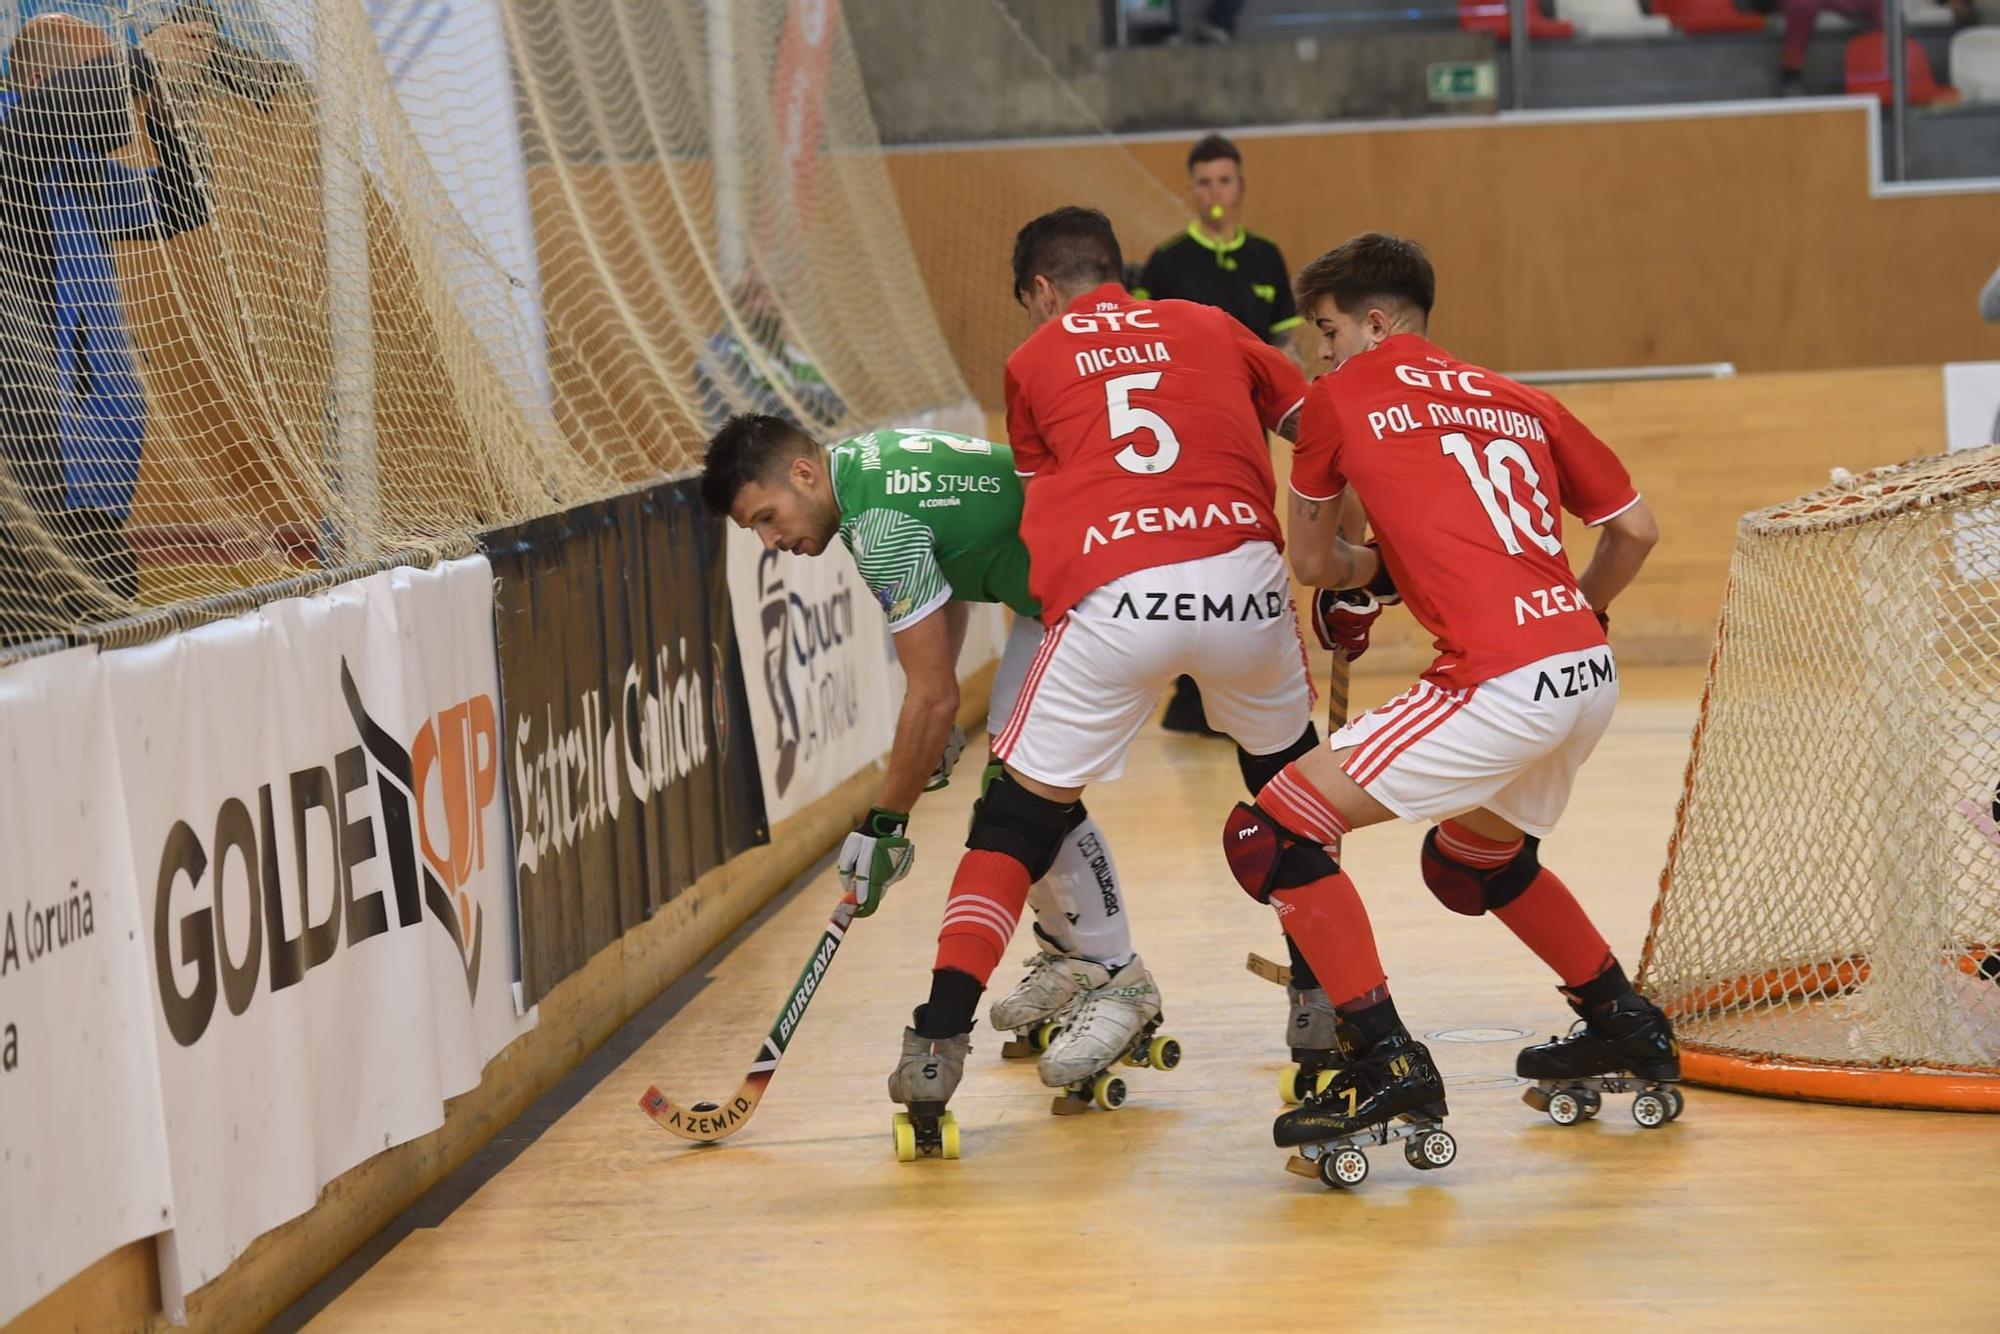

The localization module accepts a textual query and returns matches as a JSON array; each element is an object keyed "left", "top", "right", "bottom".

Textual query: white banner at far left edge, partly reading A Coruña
[{"left": 0, "top": 648, "right": 172, "bottom": 1324}]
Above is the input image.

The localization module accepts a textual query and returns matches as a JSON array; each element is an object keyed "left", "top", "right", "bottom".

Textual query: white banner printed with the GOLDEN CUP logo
[{"left": 102, "top": 558, "right": 532, "bottom": 1314}]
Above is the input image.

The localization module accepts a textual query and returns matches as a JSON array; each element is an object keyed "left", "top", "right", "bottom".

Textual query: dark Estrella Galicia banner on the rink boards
[{"left": 484, "top": 480, "right": 768, "bottom": 1002}]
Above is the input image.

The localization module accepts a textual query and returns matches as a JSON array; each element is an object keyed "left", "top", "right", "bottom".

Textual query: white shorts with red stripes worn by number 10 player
[{"left": 1326, "top": 648, "right": 1618, "bottom": 838}]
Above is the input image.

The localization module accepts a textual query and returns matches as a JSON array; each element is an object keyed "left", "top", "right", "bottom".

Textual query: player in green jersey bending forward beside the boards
[{"left": 702, "top": 414, "right": 1134, "bottom": 1056}]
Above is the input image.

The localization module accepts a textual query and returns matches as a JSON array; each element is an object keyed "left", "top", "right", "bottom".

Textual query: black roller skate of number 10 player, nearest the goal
[{"left": 1514, "top": 992, "right": 1682, "bottom": 1130}]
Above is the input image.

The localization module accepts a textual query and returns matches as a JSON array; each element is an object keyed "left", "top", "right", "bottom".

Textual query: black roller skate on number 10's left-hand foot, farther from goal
[{"left": 1270, "top": 1034, "right": 1458, "bottom": 1188}]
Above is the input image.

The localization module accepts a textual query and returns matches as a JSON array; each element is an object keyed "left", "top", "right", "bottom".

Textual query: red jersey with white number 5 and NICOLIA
[{"left": 1006, "top": 282, "right": 1306, "bottom": 624}]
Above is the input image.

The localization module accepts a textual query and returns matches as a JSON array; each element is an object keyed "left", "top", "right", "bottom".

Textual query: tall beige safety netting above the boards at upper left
[{"left": 0, "top": 0, "right": 968, "bottom": 650}]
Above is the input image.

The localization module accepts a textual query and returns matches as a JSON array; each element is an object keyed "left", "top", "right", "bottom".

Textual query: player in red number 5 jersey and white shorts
[{"left": 890, "top": 208, "right": 1332, "bottom": 1140}]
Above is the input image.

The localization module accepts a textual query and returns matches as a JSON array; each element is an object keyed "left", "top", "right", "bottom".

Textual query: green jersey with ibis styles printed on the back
[{"left": 828, "top": 430, "right": 1042, "bottom": 632}]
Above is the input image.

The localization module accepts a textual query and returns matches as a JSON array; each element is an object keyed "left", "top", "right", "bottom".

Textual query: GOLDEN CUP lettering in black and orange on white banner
[{"left": 152, "top": 658, "right": 500, "bottom": 1046}]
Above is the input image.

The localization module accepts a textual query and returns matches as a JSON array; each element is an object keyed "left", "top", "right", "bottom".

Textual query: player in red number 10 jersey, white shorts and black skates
[{"left": 1224, "top": 234, "right": 1680, "bottom": 1184}]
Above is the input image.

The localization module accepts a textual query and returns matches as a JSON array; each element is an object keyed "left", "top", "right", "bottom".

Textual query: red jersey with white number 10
[{"left": 1292, "top": 334, "right": 1638, "bottom": 688}]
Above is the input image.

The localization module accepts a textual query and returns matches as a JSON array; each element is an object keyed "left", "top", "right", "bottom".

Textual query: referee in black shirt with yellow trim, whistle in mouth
[{"left": 1132, "top": 134, "right": 1304, "bottom": 736}]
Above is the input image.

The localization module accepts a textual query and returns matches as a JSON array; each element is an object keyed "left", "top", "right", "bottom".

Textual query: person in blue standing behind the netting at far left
[{"left": 0, "top": 12, "right": 214, "bottom": 642}]
